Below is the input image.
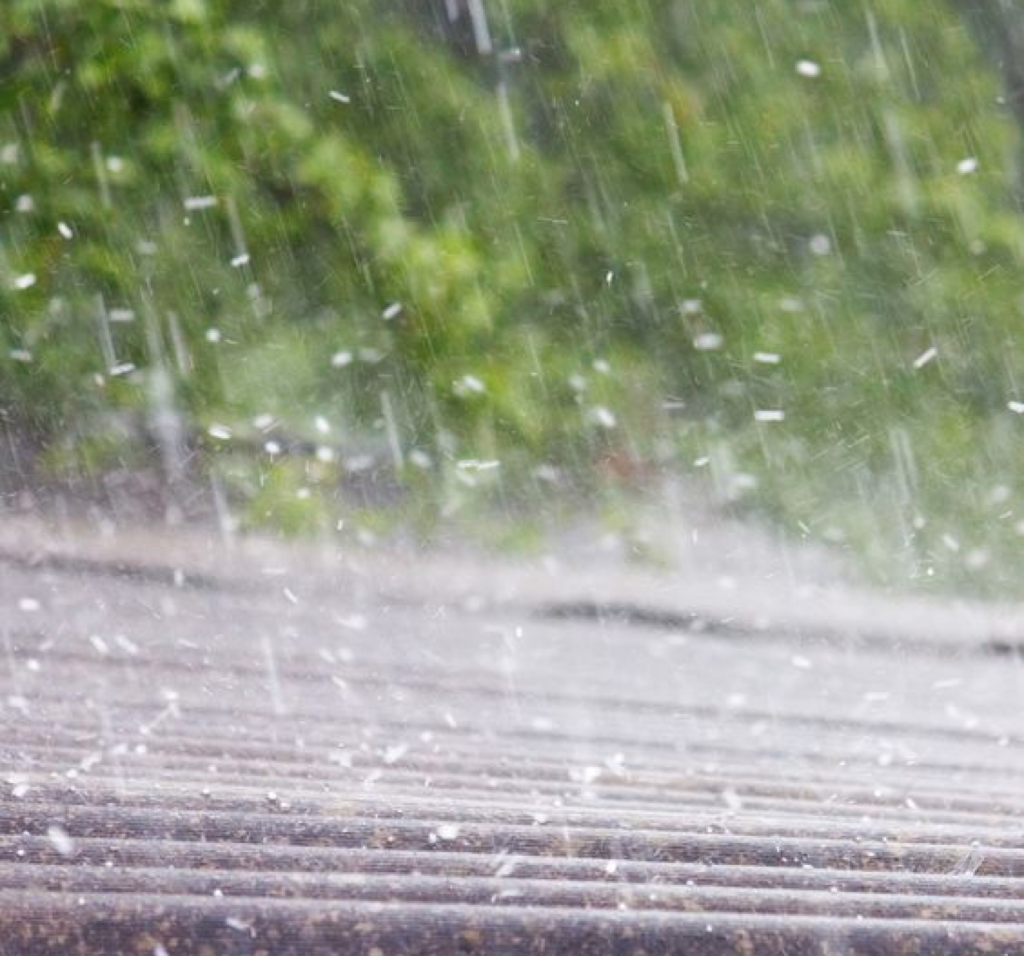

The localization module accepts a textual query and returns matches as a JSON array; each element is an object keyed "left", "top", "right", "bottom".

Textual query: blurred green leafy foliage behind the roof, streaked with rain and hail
[{"left": 0, "top": 0, "right": 1024, "bottom": 596}]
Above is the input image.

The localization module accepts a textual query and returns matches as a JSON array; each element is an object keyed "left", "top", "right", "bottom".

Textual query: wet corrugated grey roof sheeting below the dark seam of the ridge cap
[{"left": 0, "top": 544, "right": 1024, "bottom": 956}]
